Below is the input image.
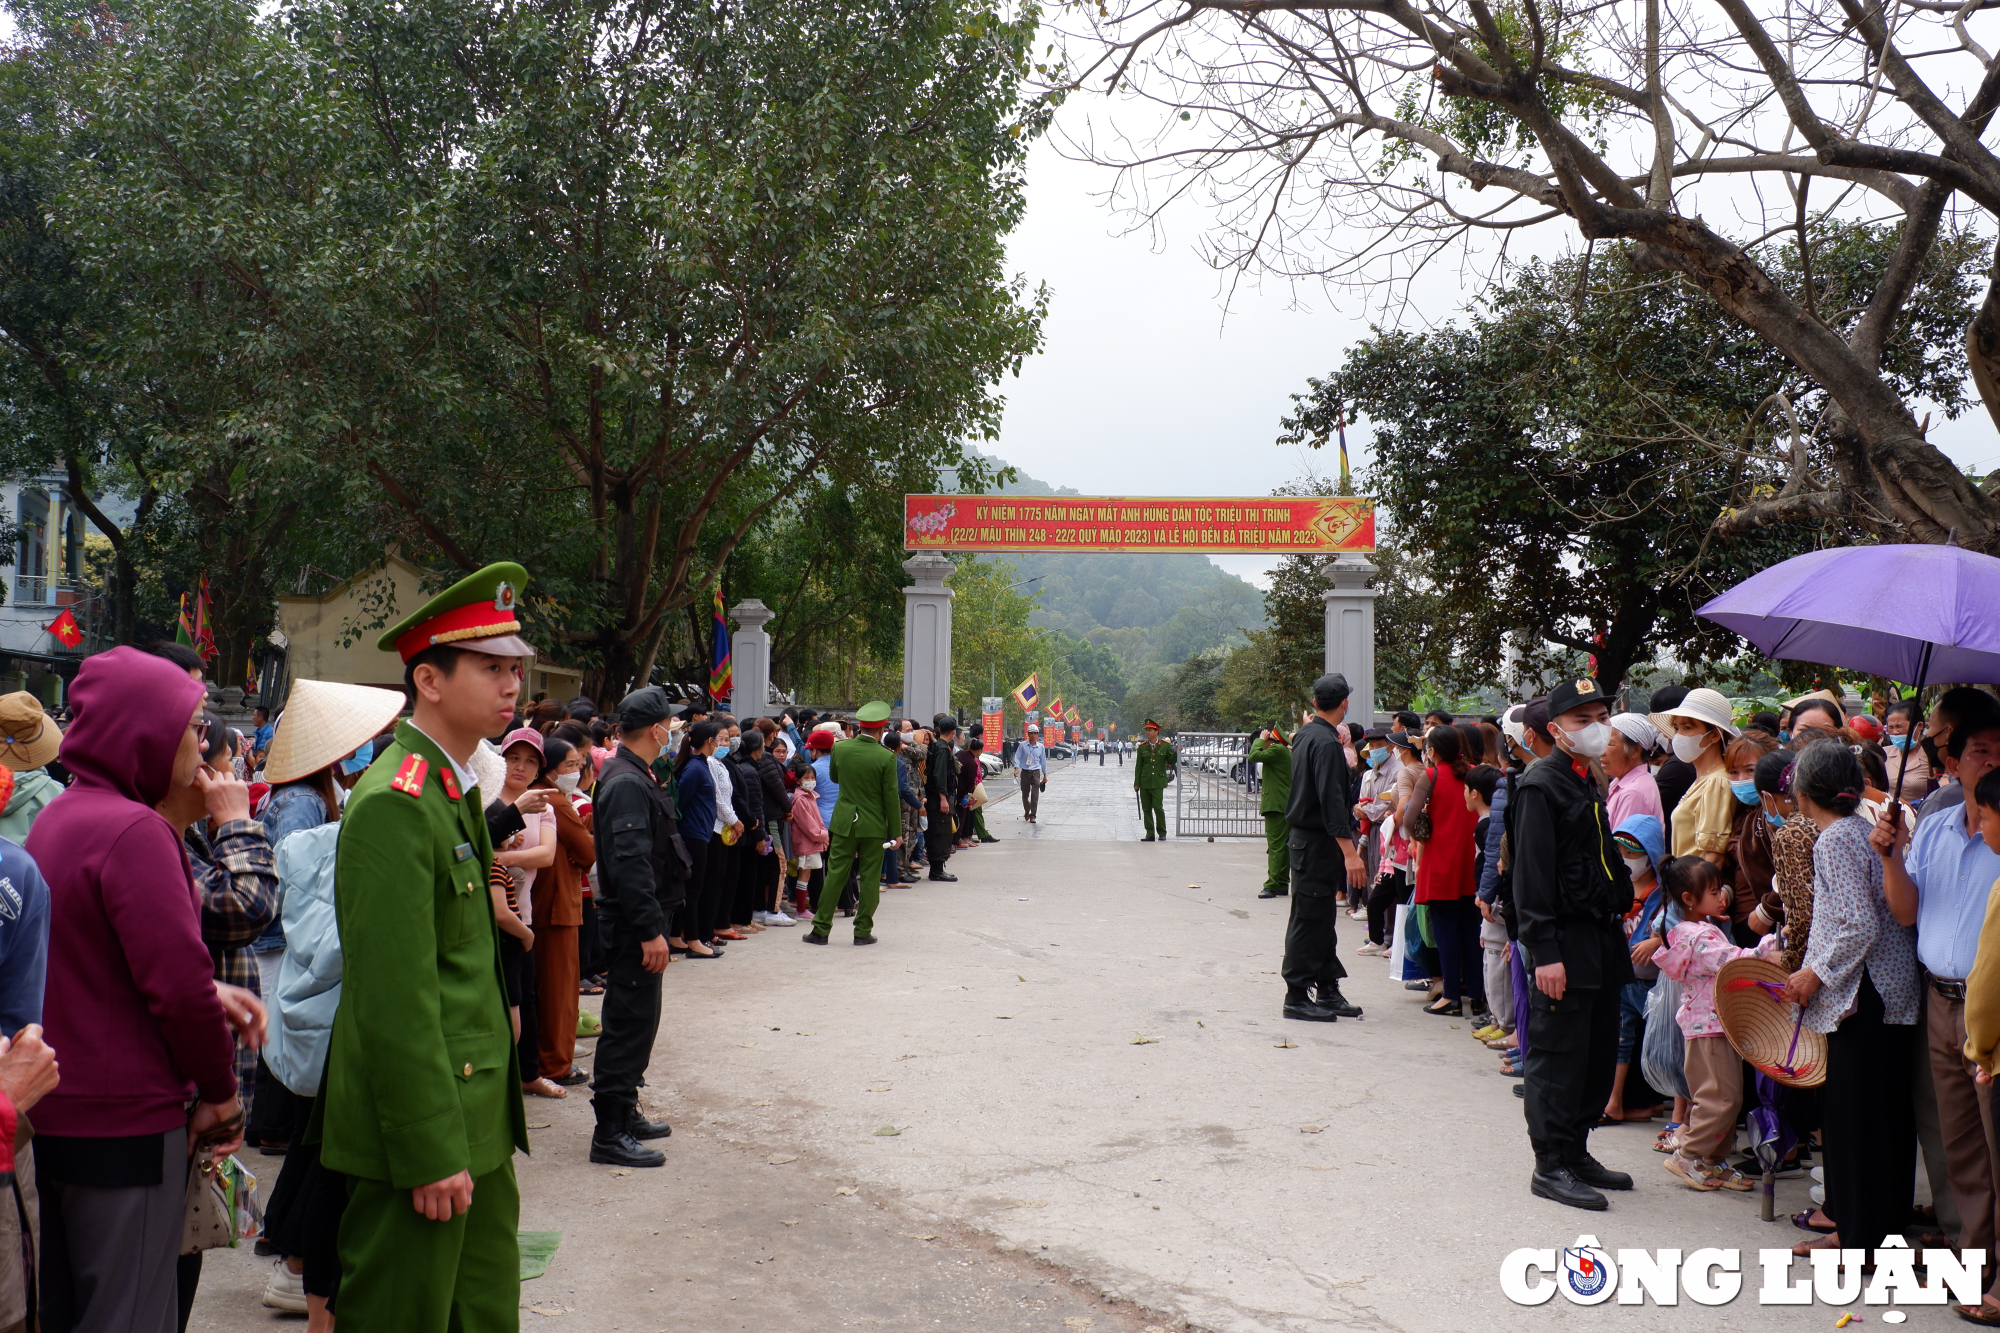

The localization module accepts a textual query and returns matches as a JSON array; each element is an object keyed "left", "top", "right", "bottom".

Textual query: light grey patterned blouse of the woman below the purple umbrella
[{"left": 1806, "top": 815, "right": 1918, "bottom": 1033}]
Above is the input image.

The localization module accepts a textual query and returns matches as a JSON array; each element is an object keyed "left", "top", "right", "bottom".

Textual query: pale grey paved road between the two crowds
[{"left": 194, "top": 765, "right": 1896, "bottom": 1333}]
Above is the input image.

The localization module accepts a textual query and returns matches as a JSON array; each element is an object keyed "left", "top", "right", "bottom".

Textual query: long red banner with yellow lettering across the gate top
[{"left": 902, "top": 494, "right": 1374, "bottom": 554}]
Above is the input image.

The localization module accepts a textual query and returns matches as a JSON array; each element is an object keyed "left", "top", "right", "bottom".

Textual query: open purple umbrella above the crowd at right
[{"left": 1696, "top": 546, "right": 2000, "bottom": 687}]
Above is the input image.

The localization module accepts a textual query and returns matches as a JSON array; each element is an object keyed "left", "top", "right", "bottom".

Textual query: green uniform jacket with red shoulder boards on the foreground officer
[{"left": 314, "top": 723, "right": 528, "bottom": 1189}]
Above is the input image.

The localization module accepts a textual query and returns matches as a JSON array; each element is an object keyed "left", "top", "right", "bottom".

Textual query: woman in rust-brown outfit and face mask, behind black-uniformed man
[{"left": 520, "top": 737, "right": 598, "bottom": 1087}]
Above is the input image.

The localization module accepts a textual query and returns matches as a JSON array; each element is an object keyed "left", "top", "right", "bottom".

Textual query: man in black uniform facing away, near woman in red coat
[{"left": 1282, "top": 675, "right": 1368, "bottom": 1023}]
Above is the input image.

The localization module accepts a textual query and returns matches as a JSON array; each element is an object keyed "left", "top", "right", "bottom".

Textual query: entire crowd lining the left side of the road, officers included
[{"left": 0, "top": 566, "right": 1032, "bottom": 1333}]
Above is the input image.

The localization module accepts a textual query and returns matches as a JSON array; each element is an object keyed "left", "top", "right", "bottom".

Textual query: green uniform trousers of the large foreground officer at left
[{"left": 340, "top": 1161, "right": 520, "bottom": 1333}]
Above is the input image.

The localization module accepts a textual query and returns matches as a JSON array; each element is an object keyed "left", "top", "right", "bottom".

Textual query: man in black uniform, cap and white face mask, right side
[{"left": 1506, "top": 677, "right": 1632, "bottom": 1209}]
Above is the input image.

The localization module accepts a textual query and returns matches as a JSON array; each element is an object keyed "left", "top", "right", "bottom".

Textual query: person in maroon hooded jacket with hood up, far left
[{"left": 28, "top": 648, "right": 262, "bottom": 1333}]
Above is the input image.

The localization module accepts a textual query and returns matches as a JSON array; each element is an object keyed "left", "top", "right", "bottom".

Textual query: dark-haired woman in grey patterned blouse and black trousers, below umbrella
[{"left": 1786, "top": 741, "right": 1918, "bottom": 1263}]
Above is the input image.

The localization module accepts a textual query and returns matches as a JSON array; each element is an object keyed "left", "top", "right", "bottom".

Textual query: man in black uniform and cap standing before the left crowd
[{"left": 590, "top": 685, "right": 686, "bottom": 1167}]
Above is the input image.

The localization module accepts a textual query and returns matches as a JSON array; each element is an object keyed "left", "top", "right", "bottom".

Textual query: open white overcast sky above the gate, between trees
[{"left": 982, "top": 140, "right": 2000, "bottom": 584}]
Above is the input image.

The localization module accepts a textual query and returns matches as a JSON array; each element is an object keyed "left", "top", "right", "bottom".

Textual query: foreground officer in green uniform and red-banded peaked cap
[{"left": 312, "top": 564, "right": 532, "bottom": 1333}]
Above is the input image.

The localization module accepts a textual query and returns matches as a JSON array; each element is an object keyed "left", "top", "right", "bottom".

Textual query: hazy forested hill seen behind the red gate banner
[{"left": 964, "top": 458, "right": 1264, "bottom": 677}]
